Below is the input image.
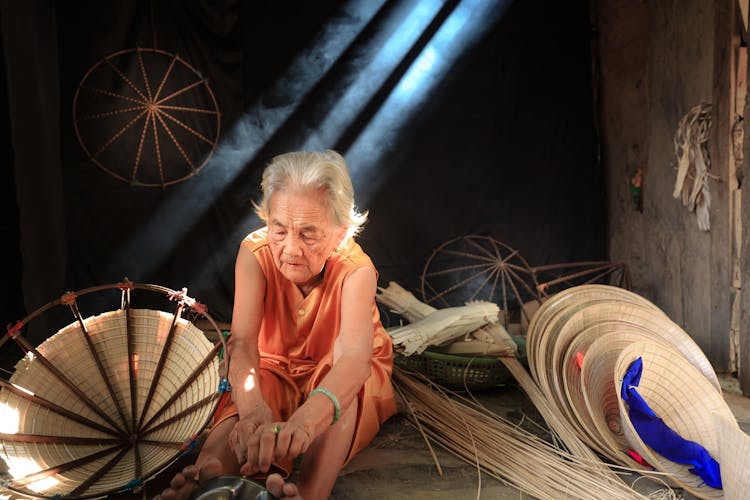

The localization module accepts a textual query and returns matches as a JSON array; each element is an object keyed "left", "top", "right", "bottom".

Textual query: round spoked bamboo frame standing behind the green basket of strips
[{"left": 421, "top": 235, "right": 540, "bottom": 327}]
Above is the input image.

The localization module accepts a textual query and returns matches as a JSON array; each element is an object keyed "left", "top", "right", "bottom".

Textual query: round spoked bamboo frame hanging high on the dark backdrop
[{"left": 73, "top": 48, "right": 221, "bottom": 188}]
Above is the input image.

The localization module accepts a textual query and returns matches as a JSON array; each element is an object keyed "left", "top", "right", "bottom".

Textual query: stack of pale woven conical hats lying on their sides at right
[{"left": 526, "top": 284, "right": 750, "bottom": 498}]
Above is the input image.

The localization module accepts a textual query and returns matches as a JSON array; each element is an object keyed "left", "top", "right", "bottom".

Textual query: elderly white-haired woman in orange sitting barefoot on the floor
[{"left": 162, "top": 151, "right": 396, "bottom": 500}]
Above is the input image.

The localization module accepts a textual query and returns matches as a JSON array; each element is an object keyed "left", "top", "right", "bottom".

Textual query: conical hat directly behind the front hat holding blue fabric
[{"left": 573, "top": 330, "right": 674, "bottom": 470}]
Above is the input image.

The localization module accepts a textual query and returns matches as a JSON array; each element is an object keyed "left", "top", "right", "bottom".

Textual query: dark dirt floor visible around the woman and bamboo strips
[{"left": 0, "top": 342, "right": 750, "bottom": 500}]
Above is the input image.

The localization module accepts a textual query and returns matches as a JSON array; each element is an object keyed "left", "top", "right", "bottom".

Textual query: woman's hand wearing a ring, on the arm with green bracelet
[{"left": 240, "top": 422, "right": 312, "bottom": 476}]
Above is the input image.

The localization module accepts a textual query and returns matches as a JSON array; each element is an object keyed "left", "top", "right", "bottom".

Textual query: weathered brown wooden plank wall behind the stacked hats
[{"left": 591, "top": 0, "right": 750, "bottom": 384}]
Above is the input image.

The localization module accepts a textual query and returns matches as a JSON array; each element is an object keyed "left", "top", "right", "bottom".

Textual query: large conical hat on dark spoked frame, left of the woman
[{"left": 0, "top": 282, "right": 228, "bottom": 498}]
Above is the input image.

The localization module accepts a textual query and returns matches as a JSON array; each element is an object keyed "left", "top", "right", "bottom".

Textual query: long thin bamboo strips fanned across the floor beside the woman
[{"left": 393, "top": 367, "right": 651, "bottom": 500}]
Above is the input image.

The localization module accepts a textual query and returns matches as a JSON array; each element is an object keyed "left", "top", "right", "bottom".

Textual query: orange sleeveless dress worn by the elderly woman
[{"left": 214, "top": 228, "right": 396, "bottom": 475}]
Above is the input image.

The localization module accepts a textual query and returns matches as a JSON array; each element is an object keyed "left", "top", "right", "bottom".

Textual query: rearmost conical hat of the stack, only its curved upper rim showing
[{"left": 526, "top": 284, "right": 664, "bottom": 386}]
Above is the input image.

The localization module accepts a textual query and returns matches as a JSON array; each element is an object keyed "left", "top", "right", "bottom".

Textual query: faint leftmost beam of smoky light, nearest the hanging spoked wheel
[{"left": 103, "top": 0, "right": 385, "bottom": 281}]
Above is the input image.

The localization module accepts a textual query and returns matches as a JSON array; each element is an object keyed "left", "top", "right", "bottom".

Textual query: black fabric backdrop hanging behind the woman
[{"left": 1, "top": 0, "right": 606, "bottom": 341}]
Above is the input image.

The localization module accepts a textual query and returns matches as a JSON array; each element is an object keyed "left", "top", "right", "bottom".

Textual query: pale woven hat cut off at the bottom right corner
[{"left": 714, "top": 413, "right": 750, "bottom": 500}]
